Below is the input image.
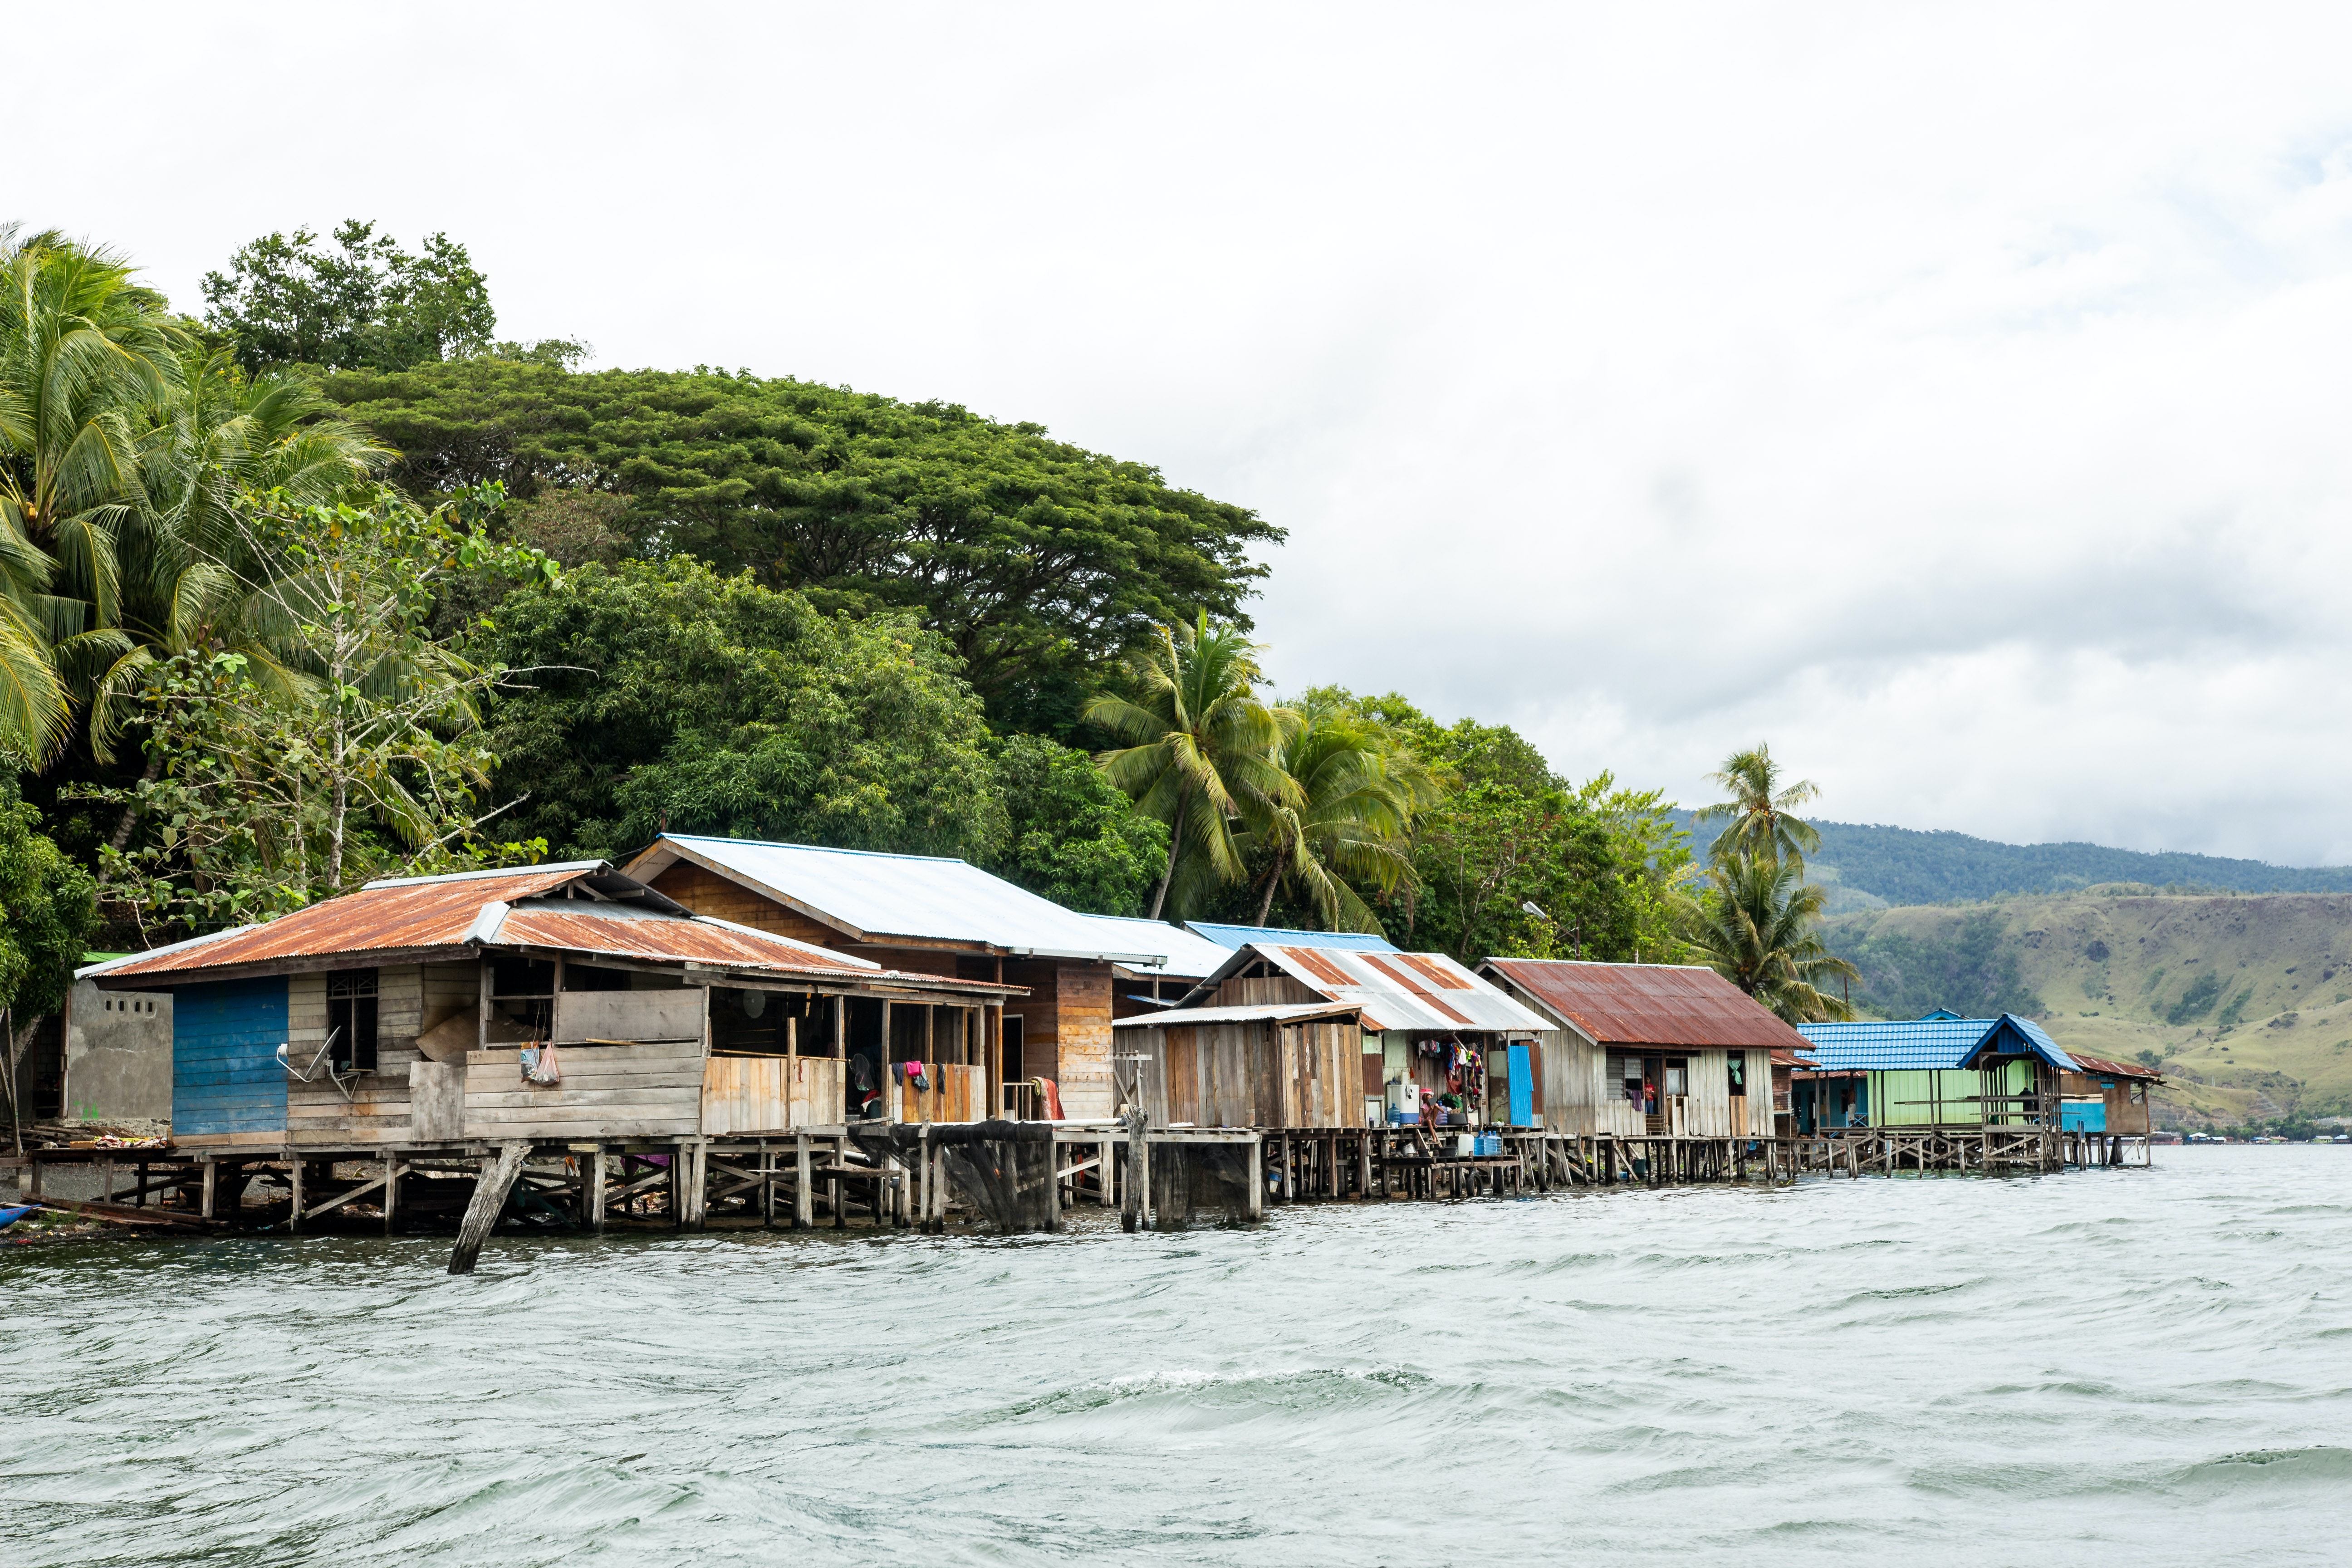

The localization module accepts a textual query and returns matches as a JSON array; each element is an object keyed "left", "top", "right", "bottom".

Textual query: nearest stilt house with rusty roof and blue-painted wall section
[{"left": 82, "top": 860, "right": 1019, "bottom": 1150}]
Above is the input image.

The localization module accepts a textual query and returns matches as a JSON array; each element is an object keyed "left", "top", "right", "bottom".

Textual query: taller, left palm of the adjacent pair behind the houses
[{"left": 1084, "top": 611, "right": 1303, "bottom": 919}]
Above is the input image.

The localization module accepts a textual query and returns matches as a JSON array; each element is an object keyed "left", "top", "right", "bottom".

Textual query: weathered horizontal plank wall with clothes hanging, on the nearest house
[{"left": 466, "top": 1041, "right": 701, "bottom": 1138}]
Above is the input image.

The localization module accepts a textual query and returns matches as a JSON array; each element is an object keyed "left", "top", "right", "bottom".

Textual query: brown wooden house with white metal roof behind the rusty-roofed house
[{"left": 628, "top": 832, "right": 1174, "bottom": 1119}]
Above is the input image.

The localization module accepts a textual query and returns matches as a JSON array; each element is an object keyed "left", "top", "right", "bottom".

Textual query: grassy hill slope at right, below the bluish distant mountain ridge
[{"left": 1823, "top": 889, "right": 2352, "bottom": 1126}]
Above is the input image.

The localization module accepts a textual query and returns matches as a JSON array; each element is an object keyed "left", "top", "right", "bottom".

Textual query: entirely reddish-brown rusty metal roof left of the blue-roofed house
[{"left": 1484, "top": 959, "right": 1811, "bottom": 1051}]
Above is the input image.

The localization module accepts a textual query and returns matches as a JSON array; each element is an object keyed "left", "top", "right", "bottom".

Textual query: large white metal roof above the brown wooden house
[{"left": 628, "top": 832, "right": 1174, "bottom": 966}]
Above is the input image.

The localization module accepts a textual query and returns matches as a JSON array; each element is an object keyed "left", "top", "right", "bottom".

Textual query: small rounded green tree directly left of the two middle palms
[{"left": 985, "top": 736, "right": 1169, "bottom": 915}]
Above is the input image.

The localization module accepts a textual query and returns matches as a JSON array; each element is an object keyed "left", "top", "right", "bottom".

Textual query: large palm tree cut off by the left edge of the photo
[{"left": 0, "top": 225, "right": 186, "bottom": 762}]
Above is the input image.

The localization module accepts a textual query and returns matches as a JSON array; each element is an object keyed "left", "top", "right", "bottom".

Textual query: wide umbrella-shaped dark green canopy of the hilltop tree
[{"left": 327, "top": 358, "right": 1282, "bottom": 734}]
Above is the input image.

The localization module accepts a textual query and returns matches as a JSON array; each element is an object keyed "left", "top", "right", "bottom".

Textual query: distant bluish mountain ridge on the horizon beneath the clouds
[{"left": 1679, "top": 811, "right": 2352, "bottom": 907}]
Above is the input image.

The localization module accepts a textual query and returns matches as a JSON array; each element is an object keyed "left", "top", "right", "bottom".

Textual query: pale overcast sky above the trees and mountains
[{"left": 18, "top": 0, "right": 2352, "bottom": 865}]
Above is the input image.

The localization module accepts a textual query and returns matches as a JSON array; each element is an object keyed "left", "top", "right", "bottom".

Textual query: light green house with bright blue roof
[{"left": 1790, "top": 1013, "right": 2079, "bottom": 1133}]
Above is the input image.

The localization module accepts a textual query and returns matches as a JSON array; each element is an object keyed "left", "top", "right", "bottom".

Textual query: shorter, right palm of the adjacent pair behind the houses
[{"left": 1247, "top": 694, "right": 1440, "bottom": 931}]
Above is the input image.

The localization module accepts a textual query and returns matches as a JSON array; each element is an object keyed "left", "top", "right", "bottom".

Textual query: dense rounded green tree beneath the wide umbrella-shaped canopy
[{"left": 475, "top": 559, "right": 1004, "bottom": 860}]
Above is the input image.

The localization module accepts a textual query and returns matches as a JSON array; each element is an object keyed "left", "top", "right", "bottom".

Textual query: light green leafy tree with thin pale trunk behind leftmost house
[{"left": 73, "top": 487, "right": 555, "bottom": 941}]
